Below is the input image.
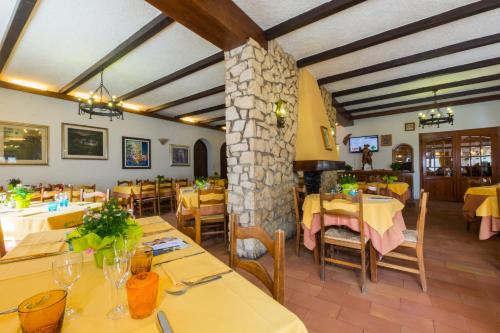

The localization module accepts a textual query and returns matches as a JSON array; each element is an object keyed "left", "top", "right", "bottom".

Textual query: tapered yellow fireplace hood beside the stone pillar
[{"left": 293, "top": 69, "right": 345, "bottom": 172}]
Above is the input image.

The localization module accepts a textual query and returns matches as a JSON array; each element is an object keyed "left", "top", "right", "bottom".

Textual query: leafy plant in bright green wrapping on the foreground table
[{"left": 67, "top": 200, "right": 142, "bottom": 268}]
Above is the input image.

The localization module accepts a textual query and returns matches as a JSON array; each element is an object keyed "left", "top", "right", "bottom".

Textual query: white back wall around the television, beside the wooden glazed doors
[{"left": 337, "top": 101, "right": 500, "bottom": 197}]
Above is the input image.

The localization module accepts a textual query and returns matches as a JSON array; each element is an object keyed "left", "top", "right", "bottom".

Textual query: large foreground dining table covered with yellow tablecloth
[{"left": 0, "top": 216, "right": 307, "bottom": 333}]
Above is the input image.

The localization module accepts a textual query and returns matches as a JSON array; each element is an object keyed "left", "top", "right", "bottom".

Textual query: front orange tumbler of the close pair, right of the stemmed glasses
[{"left": 127, "top": 272, "right": 158, "bottom": 319}]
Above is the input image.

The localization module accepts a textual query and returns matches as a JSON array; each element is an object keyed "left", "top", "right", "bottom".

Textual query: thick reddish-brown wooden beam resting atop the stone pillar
[{"left": 146, "top": 0, "right": 267, "bottom": 51}]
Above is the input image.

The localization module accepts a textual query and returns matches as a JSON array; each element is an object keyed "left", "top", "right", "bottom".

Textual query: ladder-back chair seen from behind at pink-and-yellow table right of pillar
[{"left": 320, "top": 191, "right": 369, "bottom": 293}]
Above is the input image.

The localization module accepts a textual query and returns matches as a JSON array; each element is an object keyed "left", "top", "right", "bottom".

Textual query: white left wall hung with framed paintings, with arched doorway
[{"left": 0, "top": 88, "right": 225, "bottom": 189}]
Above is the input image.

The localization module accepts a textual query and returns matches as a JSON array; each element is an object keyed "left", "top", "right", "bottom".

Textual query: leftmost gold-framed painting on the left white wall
[{"left": 0, "top": 121, "right": 49, "bottom": 165}]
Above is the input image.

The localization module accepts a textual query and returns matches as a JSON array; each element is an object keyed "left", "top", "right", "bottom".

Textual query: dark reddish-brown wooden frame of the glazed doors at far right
[{"left": 418, "top": 126, "right": 500, "bottom": 200}]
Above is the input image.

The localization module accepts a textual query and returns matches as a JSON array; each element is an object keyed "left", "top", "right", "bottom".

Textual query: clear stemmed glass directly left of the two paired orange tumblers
[{"left": 102, "top": 251, "right": 131, "bottom": 320}]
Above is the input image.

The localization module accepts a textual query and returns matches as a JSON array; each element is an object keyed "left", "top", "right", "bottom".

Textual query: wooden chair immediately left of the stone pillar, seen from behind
[{"left": 193, "top": 188, "right": 228, "bottom": 245}]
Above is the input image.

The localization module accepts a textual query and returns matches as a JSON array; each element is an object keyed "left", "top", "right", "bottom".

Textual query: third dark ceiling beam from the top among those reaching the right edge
[{"left": 332, "top": 57, "right": 500, "bottom": 97}]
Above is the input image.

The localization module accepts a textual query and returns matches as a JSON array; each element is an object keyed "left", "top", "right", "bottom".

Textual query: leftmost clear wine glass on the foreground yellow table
[{"left": 52, "top": 252, "right": 83, "bottom": 319}]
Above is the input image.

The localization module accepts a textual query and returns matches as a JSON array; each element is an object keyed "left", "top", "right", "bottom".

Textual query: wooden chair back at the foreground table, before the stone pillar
[{"left": 229, "top": 214, "right": 285, "bottom": 304}]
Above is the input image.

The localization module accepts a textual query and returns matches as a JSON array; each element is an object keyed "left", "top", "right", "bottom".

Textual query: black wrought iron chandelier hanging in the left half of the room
[{"left": 78, "top": 71, "right": 123, "bottom": 121}]
